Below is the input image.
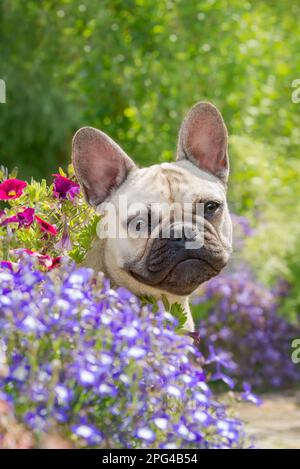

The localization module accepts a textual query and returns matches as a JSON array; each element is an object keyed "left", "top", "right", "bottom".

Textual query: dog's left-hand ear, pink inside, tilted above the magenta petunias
[{"left": 72, "top": 127, "right": 135, "bottom": 206}]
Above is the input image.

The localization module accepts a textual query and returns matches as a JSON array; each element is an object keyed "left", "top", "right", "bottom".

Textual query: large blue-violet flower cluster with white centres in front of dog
[{"left": 0, "top": 258, "right": 247, "bottom": 448}]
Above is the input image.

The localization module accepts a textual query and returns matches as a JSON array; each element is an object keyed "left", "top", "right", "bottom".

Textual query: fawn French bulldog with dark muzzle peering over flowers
[{"left": 72, "top": 102, "right": 232, "bottom": 332}]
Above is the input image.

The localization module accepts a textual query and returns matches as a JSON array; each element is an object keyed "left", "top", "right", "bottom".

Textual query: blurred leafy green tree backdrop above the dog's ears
[{"left": 0, "top": 0, "right": 300, "bottom": 177}]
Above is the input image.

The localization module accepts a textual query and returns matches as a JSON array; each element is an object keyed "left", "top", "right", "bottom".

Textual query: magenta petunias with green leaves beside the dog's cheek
[{"left": 0, "top": 168, "right": 99, "bottom": 269}]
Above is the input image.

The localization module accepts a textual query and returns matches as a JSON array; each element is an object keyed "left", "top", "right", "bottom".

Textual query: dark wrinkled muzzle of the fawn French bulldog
[{"left": 127, "top": 221, "right": 229, "bottom": 295}]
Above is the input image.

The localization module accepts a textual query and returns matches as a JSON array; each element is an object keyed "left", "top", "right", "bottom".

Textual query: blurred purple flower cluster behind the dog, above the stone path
[{"left": 193, "top": 270, "right": 300, "bottom": 389}]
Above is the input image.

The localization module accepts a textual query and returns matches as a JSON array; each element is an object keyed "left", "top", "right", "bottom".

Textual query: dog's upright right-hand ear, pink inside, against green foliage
[{"left": 177, "top": 102, "right": 229, "bottom": 183}]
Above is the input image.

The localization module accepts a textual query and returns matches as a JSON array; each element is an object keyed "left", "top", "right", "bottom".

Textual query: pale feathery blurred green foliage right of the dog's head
[{"left": 229, "top": 137, "right": 300, "bottom": 292}]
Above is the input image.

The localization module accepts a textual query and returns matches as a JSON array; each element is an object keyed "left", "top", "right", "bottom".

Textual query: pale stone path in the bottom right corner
[{"left": 235, "top": 390, "right": 300, "bottom": 449}]
